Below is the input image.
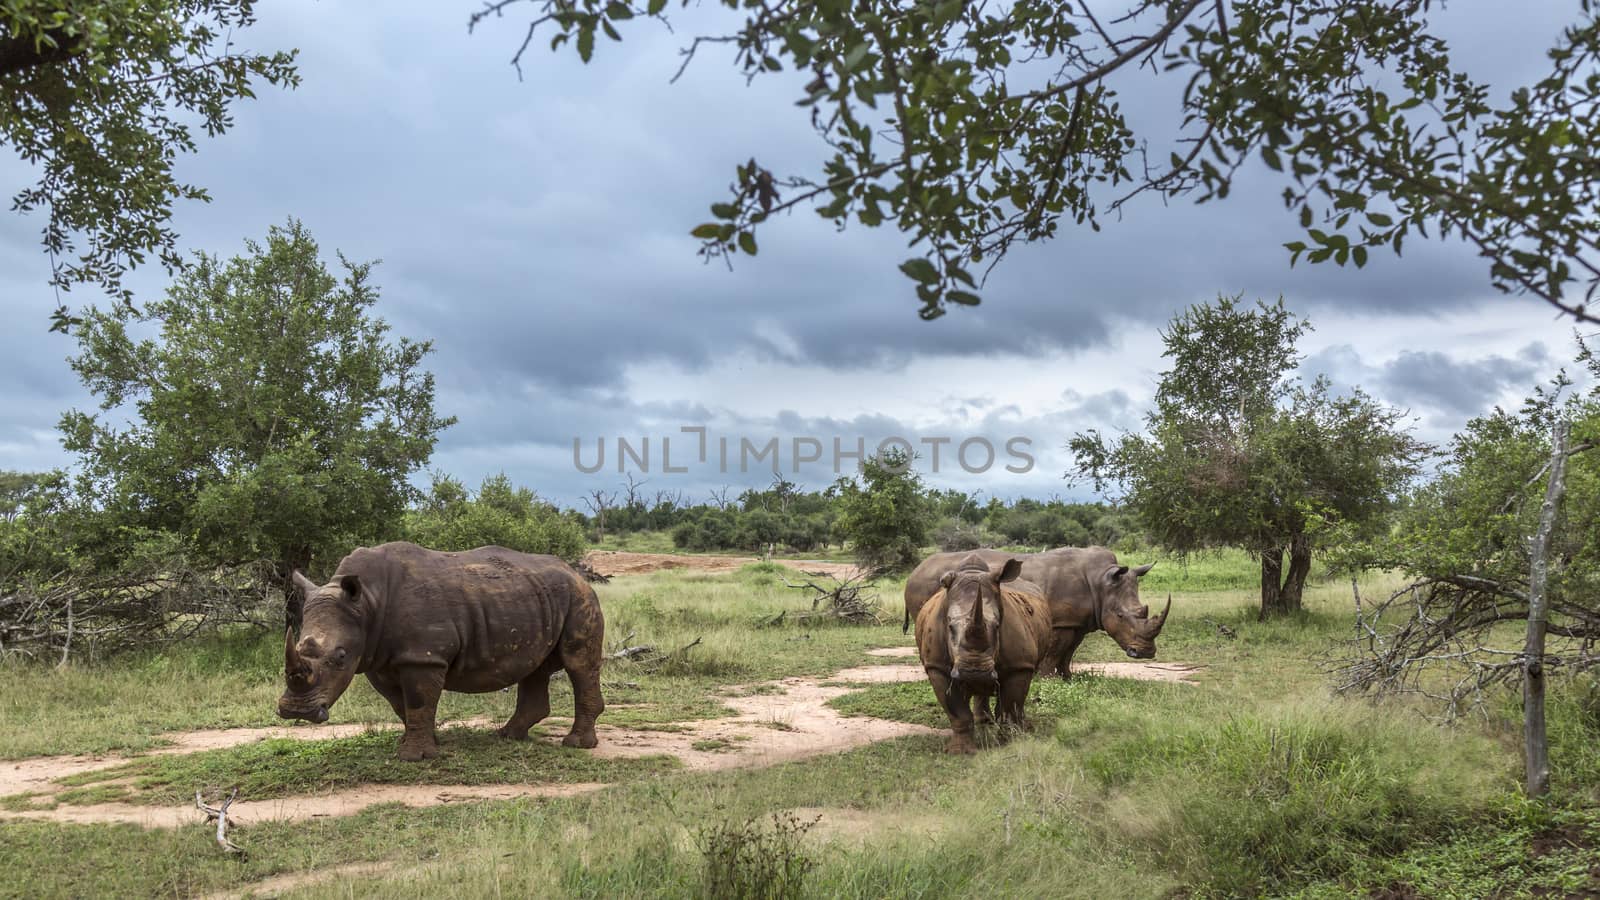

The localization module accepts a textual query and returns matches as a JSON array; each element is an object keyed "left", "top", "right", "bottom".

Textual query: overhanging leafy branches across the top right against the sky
[{"left": 469, "top": 0, "right": 1600, "bottom": 319}]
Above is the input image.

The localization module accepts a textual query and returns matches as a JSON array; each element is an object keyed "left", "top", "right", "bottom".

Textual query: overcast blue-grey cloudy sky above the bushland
[{"left": 0, "top": 0, "right": 1576, "bottom": 504}]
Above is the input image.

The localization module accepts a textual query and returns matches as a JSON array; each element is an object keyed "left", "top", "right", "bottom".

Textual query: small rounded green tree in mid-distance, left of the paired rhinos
[{"left": 834, "top": 447, "right": 930, "bottom": 572}]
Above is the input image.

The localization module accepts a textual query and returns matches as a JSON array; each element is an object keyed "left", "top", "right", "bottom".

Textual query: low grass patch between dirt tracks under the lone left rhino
[{"left": 56, "top": 727, "right": 678, "bottom": 804}]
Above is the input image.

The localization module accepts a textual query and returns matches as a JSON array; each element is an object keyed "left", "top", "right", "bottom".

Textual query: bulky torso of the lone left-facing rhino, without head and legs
[{"left": 338, "top": 543, "right": 594, "bottom": 692}]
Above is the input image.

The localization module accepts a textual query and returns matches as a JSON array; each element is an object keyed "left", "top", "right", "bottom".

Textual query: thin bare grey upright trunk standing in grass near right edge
[{"left": 1522, "top": 421, "right": 1566, "bottom": 798}]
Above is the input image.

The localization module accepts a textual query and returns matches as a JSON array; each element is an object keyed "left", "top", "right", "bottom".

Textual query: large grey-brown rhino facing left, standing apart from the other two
[{"left": 278, "top": 543, "right": 605, "bottom": 761}]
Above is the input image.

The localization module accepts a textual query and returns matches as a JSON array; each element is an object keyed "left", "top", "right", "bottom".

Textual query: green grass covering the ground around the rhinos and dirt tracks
[{"left": 0, "top": 557, "right": 1600, "bottom": 900}]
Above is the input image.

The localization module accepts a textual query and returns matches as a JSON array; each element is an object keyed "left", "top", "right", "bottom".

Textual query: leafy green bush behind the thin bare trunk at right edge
[{"left": 1336, "top": 340, "right": 1600, "bottom": 717}]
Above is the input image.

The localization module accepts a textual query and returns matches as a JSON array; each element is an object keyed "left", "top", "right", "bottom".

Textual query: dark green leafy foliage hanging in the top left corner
[{"left": 0, "top": 0, "right": 299, "bottom": 330}]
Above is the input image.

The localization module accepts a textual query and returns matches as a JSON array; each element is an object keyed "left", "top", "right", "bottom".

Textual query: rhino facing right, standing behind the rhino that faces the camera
[{"left": 906, "top": 548, "right": 1173, "bottom": 677}]
